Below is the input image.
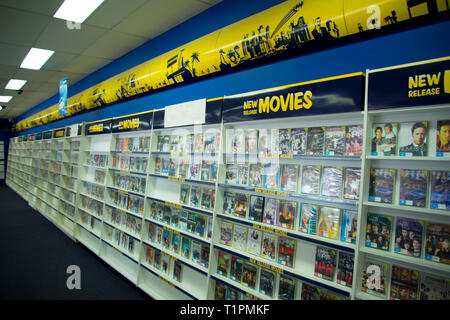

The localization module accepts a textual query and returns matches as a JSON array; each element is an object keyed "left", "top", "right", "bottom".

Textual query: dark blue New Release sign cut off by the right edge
[{"left": 368, "top": 57, "right": 450, "bottom": 110}]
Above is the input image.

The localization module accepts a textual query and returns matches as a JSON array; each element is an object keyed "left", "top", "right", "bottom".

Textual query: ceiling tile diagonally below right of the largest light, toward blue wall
[{"left": 83, "top": 31, "right": 147, "bottom": 60}]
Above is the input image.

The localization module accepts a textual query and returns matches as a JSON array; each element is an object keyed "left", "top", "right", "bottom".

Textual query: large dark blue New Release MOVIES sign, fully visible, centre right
[{"left": 222, "top": 73, "right": 364, "bottom": 122}]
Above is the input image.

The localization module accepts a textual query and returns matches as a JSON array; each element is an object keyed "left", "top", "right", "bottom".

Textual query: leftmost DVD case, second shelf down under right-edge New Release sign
[{"left": 369, "top": 168, "right": 396, "bottom": 203}]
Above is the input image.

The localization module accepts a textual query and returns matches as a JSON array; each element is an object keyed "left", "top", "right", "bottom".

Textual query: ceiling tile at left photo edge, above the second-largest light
[{"left": 0, "top": 7, "right": 51, "bottom": 46}]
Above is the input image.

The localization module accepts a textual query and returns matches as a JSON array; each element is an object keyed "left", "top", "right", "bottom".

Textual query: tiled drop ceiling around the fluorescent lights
[{"left": 0, "top": 0, "right": 222, "bottom": 119}]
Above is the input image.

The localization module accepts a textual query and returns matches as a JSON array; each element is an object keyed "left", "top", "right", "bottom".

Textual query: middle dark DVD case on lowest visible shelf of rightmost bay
[{"left": 390, "top": 265, "right": 420, "bottom": 300}]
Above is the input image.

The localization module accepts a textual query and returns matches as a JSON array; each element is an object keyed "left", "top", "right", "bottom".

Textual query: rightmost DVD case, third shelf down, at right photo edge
[{"left": 425, "top": 223, "right": 450, "bottom": 264}]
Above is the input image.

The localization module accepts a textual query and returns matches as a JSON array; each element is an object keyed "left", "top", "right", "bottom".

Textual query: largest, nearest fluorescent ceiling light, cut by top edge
[{"left": 53, "top": 0, "right": 104, "bottom": 23}]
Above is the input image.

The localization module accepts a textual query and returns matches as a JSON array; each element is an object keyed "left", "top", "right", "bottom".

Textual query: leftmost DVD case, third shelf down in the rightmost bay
[{"left": 365, "top": 213, "right": 392, "bottom": 251}]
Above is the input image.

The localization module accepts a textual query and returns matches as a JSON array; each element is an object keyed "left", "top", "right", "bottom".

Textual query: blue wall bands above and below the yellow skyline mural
[{"left": 15, "top": 0, "right": 450, "bottom": 135}]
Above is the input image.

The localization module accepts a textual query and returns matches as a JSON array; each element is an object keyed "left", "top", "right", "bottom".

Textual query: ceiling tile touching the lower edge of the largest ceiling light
[{"left": 35, "top": 19, "right": 107, "bottom": 54}]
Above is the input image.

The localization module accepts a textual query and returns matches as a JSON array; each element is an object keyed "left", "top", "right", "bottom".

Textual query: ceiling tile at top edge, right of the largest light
[{"left": 113, "top": 0, "right": 210, "bottom": 39}]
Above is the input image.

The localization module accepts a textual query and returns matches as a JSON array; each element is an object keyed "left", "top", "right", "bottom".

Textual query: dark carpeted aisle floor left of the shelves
[{"left": 0, "top": 186, "right": 150, "bottom": 300}]
